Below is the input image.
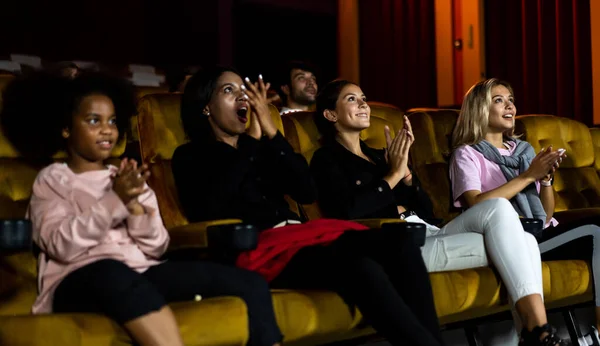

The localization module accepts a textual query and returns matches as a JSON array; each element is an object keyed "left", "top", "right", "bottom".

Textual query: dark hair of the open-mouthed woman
[{"left": 181, "top": 66, "right": 239, "bottom": 142}]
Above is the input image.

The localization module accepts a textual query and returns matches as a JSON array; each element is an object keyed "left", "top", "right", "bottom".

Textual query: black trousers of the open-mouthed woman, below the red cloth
[{"left": 271, "top": 230, "right": 443, "bottom": 346}]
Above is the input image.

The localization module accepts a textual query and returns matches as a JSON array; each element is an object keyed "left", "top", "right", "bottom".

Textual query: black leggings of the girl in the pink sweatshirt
[{"left": 53, "top": 259, "right": 282, "bottom": 346}]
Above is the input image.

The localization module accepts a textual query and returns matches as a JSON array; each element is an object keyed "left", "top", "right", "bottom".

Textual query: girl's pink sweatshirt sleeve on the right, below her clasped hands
[{"left": 127, "top": 186, "right": 169, "bottom": 259}]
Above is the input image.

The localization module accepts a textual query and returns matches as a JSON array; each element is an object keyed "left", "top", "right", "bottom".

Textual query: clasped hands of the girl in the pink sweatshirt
[{"left": 113, "top": 158, "right": 150, "bottom": 212}]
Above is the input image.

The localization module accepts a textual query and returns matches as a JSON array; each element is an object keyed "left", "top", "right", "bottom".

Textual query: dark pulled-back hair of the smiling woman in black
[{"left": 314, "top": 79, "right": 354, "bottom": 143}]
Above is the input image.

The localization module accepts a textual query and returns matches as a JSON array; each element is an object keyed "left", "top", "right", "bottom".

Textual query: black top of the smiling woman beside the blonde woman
[{"left": 310, "top": 141, "right": 433, "bottom": 220}]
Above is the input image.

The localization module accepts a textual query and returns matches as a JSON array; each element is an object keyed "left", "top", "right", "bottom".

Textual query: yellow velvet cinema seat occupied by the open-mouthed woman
[{"left": 138, "top": 94, "right": 384, "bottom": 345}]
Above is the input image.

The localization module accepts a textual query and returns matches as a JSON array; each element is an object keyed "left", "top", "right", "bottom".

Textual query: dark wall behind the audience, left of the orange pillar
[{"left": 0, "top": 0, "right": 337, "bottom": 79}]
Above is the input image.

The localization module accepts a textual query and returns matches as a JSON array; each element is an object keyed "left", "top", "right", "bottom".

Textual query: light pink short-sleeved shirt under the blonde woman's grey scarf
[{"left": 450, "top": 145, "right": 558, "bottom": 227}]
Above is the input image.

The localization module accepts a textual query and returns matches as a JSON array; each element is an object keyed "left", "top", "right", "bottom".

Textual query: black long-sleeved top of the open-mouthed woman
[{"left": 172, "top": 133, "right": 316, "bottom": 229}]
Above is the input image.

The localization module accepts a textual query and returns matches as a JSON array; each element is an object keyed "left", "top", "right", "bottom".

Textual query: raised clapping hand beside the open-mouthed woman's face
[{"left": 242, "top": 75, "right": 277, "bottom": 138}]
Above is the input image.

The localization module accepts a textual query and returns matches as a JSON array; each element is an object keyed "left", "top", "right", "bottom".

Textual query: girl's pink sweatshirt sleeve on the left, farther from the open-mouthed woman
[{"left": 29, "top": 170, "right": 129, "bottom": 263}]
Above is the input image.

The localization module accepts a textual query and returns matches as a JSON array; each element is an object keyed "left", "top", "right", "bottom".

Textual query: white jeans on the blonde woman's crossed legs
[{"left": 418, "top": 198, "right": 543, "bottom": 302}]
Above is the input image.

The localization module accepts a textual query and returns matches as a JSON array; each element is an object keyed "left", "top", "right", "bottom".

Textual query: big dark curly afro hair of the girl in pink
[{"left": 0, "top": 71, "right": 137, "bottom": 159}]
